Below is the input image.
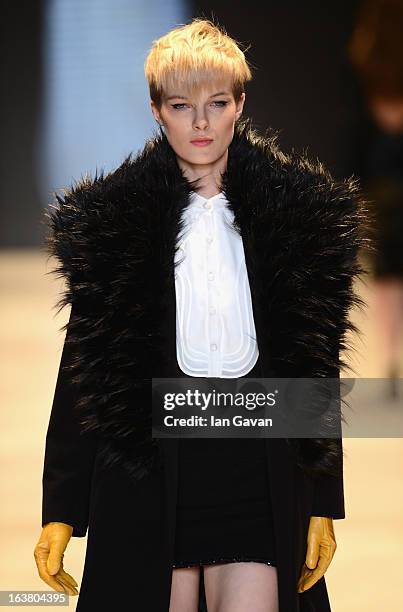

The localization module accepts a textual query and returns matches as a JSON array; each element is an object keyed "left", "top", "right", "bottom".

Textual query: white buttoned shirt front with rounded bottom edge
[{"left": 175, "top": 192, "right": 259, "bottom": 378}]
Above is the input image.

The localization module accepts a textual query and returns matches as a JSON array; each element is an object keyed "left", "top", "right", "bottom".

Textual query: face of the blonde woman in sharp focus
[{"left": 151, "top": 78, "right": 245, "bottom": 171}]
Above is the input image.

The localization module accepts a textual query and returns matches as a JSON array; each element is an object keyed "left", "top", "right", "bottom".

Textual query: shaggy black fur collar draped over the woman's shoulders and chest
[{"left": 45, "top": 119, "right": 368, "bottom": 478}]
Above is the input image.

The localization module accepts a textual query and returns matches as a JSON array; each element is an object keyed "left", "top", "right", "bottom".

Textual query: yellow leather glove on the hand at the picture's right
[{"left": 298, "top": 516, "right": 337, "bottom": 593}]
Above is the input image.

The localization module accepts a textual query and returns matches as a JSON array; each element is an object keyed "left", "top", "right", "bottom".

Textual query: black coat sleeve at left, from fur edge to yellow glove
[{"left": 42, "top": 306, "right": 97, "bottom": 537}]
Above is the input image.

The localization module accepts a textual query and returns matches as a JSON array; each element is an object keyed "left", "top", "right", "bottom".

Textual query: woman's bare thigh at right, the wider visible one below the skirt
[{"left": 203, "top": 561, "right": 278, "bottom": 612}]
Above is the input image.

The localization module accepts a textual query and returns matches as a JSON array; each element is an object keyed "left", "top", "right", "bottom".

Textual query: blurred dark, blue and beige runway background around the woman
[{"left": 0, "top": 0, "right": 403, "bottom": 612}]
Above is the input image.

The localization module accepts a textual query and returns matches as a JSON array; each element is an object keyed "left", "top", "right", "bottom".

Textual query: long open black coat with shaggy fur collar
[{"left": 42, "top": 119, "right": 366, "bottom": 612}]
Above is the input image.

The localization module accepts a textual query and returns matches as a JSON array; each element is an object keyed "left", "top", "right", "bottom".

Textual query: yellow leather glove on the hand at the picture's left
[{"left": 34, "top": 522, "right": 78, "bottom": 595}]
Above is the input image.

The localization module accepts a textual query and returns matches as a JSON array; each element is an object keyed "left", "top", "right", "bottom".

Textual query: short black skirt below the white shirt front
[{"left": 173, "top": 358, "right": 276, "bottom": 568}]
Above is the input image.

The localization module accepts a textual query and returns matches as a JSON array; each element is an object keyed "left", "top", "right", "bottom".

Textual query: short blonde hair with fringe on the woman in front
[{"left": 144, "top": 17, "right": 252, "bottom": 108}]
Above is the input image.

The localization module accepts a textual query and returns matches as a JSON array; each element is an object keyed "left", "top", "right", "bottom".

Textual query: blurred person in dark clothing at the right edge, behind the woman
[{"left": 348, "top": 0, "right": 403, "bottom": 394}]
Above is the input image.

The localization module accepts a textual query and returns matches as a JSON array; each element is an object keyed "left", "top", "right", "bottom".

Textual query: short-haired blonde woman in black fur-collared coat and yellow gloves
[{"left": 35, "top": 18, "right": 365, "bottom": 612}]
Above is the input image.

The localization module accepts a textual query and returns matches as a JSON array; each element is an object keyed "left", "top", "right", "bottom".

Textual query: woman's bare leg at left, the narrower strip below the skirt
[{"left": 169, "top": 565, "right": 200, "bottom": 612}]
